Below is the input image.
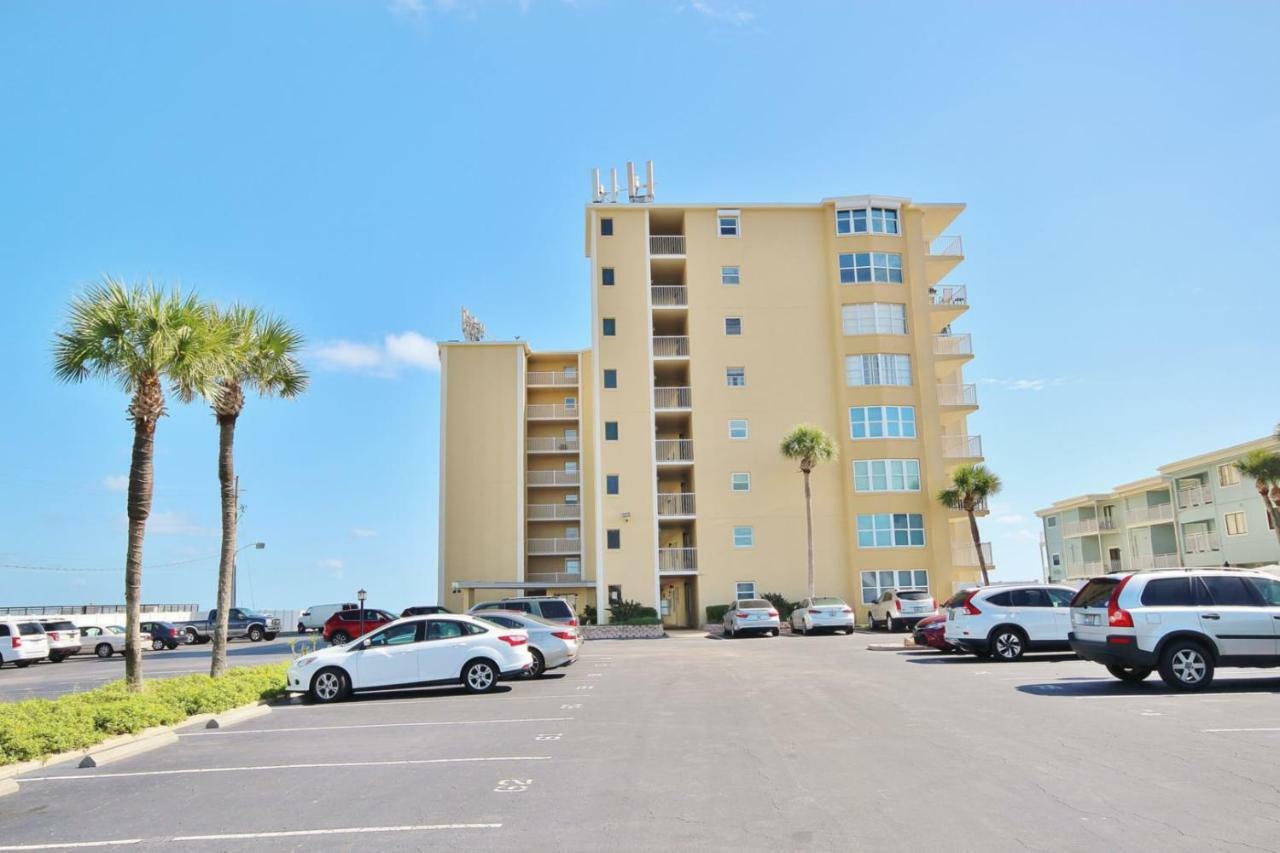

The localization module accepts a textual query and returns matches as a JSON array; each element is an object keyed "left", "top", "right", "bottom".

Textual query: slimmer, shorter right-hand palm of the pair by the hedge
[{"left": 207, "top": 305, "right": 307, "bottom": 676}]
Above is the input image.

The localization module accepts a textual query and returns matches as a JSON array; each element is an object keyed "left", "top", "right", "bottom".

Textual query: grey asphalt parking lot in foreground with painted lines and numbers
[{"left": 0, "top": 633, "right": 1280, "bottom": 853}]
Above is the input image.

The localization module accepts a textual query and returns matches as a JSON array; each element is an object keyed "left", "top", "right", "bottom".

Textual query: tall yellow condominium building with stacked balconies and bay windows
[{"left": 439, "top": 184, "right": 991, "bottom": 626}]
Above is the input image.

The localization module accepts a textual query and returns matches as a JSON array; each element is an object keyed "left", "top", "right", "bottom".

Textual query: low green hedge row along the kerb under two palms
[{"left": 0, "top": 662, "right": 289, "bottom": 765}]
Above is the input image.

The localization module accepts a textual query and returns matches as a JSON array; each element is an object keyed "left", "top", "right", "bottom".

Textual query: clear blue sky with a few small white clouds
[{"left": 0, "top": 0, "right": 1280, "bottom": 607}]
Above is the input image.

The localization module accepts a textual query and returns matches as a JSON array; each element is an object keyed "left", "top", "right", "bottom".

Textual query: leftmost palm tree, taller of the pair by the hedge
[{"left": 54, "top": 277, "right": 225, "bottom": 693}]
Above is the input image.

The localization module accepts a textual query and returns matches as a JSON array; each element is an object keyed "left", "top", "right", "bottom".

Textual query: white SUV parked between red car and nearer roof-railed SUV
[{"left": 945, "top": 584, "right": 1075, "bottom": 661}]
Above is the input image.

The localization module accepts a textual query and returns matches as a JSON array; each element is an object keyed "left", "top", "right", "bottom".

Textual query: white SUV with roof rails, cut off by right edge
[{"left": 1070, "top": 569, "right": 1280, "bottom": 690}]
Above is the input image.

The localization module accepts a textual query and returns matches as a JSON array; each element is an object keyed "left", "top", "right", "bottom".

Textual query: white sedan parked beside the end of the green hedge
[{"left": 285, "top": 615, "right": 534, "bottom": 702}]
